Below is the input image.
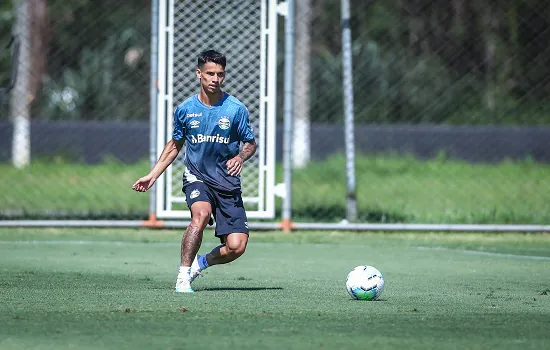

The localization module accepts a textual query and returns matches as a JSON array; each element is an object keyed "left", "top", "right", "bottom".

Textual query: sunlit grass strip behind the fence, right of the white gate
[{"left": 293, "top": 156, "right": 550, "bottom": 224}]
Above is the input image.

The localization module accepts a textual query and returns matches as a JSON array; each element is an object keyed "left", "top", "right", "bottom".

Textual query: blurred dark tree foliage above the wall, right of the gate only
[{"left": 311, "top": 0, "right": 550, "bottom": 124}]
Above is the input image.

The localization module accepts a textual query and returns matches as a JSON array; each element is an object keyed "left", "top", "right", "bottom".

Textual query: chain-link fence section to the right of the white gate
[{"left": 293, "top": 0, "right": 550, "bottom": 224}]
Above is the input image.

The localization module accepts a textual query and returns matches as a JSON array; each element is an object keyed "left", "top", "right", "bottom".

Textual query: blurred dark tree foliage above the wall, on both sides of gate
[{"left": 0, "top": 0, "right": 550, "bottom": 124}]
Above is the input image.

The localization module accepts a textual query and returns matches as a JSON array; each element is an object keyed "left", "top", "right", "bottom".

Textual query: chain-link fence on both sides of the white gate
[{"left": 0, "top": 0, "right": 550, "bottom": 224}]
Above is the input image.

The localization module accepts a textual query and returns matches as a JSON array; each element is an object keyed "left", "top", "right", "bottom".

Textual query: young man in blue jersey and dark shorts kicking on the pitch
[{"left": 132, "top": 50, "right": 256, "bottom": 293}]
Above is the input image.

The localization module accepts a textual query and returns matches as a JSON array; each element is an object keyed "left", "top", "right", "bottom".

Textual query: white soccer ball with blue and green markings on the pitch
[{"left": 346, "top": 265, "right": 384, "bottom": 300}]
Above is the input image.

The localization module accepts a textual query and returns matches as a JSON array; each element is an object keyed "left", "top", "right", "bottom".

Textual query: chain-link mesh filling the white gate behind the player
[{"left": 166, "top": 1, "right": 262, "bottom": 214}]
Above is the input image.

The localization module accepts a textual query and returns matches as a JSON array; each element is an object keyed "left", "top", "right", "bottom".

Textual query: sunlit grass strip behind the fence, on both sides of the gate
[{"left": 0, "top": 155, "right": 550, "bottom": 224}]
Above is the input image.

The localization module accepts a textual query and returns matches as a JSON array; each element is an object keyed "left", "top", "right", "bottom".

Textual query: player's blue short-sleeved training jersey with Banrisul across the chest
[{"left": 172, "top": 93, "right": 254, "bottom": 193}]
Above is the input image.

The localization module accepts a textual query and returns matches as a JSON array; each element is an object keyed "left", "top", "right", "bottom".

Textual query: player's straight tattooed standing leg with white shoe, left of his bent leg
[{"left": 176, "top": 182, "right": 212, "bottom": 292}]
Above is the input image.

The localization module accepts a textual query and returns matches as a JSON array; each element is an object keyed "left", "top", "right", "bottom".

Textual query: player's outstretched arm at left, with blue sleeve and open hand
[{"left": 132, "top": 107, "right": 185, "bottom": 192}]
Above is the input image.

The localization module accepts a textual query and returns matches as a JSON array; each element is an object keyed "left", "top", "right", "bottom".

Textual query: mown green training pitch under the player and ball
[{"left": 0, "top": 228, "right": 550, "bottom": 350}]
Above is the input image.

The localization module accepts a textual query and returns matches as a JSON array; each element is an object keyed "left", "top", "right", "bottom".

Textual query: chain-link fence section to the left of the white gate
[{"left": 0, "top": 0, "right": 151, "bottom": 219}]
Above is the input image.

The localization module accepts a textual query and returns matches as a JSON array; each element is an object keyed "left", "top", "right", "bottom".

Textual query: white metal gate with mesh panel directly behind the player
[{"left": 154, "top": 0, "right": 277, "bottom": 219}]
